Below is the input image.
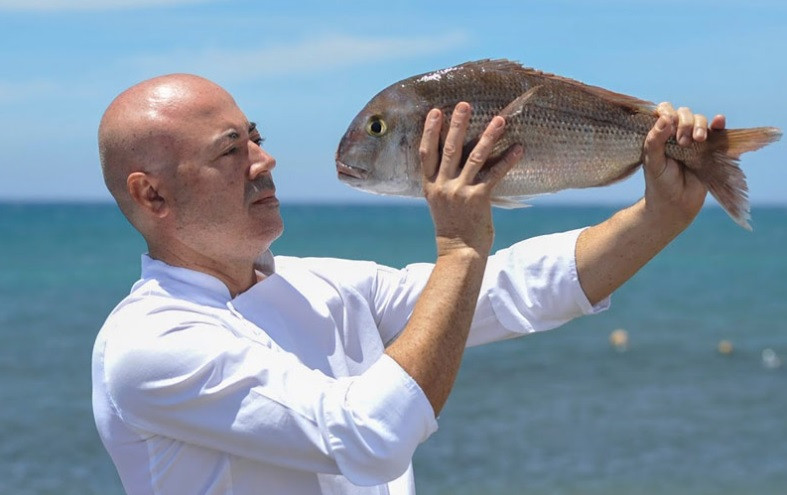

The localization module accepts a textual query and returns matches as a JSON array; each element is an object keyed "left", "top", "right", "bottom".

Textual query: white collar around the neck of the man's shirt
[{"left": 138, "top": 250, "right": 276, "bottom": 306}]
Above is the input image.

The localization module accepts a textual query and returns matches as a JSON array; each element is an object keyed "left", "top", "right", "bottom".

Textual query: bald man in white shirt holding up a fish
[{"left": 93, "top": 74, "right": 724, "bottom": 495}]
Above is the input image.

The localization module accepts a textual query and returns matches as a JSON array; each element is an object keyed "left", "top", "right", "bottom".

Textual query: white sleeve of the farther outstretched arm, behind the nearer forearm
[{"left": 374, "top": 229, "right": 609, "bottom": 346}]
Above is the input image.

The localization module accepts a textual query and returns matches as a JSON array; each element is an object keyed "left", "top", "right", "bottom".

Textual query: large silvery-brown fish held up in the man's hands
[{"left": 336, "top": 59, "right": 782, "bottom": 230}]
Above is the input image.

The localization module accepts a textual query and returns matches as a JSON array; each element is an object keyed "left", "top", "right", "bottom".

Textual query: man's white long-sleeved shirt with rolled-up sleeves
[{"left": 93, "top": 230, "right": 608, "bottom": 495}]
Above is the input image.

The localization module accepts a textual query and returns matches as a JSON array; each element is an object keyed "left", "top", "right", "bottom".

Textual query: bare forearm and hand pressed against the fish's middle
[{"left": 385, "top": 103, "right": 522, "bottom": 414}]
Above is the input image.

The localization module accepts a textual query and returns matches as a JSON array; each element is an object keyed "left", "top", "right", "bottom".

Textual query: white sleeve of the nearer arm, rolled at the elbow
[{"left": 103, "top": 312, "right": 437, "bottom": 485}]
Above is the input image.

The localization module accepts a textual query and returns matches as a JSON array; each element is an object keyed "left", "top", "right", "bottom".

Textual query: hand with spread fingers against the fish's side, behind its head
[{"left": 419, "top": 102, "right": 522, "bottom": 257}]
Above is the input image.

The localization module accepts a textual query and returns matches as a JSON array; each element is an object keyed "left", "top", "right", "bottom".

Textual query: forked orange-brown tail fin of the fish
[{"left": 687, "top": 127, "right": 782, "bottom": 230}]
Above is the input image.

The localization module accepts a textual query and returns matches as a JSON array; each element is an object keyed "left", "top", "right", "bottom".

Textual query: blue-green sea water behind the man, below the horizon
[{"left": 0, "top": 204, "right": 787, "bottom": 495}]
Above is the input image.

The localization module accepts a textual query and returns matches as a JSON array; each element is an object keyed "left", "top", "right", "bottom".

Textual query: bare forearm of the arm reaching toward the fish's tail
[{"left": 576, "top": 199, "right": 687, "bottom": 304}]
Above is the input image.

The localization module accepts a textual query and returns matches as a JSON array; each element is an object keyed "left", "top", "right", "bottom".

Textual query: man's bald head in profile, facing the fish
[{"left": 98, "top": 74, "right": 283, "bottom": 282}]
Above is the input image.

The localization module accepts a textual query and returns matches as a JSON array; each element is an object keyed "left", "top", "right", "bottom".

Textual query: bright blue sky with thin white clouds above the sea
[{"left": 0, "top": 0, "right": 787, "bottom": 204}]
